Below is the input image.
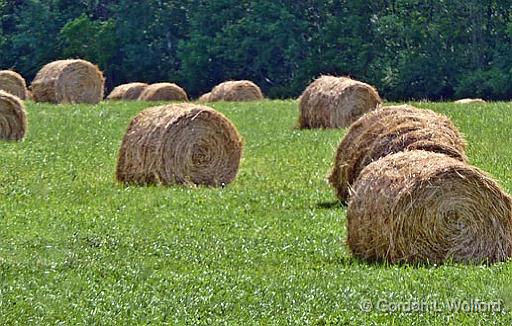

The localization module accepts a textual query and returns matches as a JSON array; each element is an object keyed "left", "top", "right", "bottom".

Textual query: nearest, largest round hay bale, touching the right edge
[{"left": 347, "top": 151, "right": 512, "bottom": 264}]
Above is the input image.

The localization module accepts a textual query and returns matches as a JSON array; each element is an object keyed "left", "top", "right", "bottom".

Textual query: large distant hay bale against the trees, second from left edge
[{"left": 32, "top": 59, "right": 105, "bottom": 104}]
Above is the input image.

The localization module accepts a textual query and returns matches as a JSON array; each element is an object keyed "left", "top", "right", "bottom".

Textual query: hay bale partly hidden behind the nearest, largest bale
[{"left": 328, "top": 105, "right": 466, "bottom": 202}]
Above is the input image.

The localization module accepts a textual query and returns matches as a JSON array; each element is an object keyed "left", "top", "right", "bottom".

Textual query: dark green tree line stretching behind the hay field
[{"left": 0, "top": 0, "right": 512, "bottom": 100}]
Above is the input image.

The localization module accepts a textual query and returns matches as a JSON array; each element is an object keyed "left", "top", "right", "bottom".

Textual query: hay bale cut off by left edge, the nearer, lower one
[{"left": 0, "top": 90, "right": 27, "bottom": 140}]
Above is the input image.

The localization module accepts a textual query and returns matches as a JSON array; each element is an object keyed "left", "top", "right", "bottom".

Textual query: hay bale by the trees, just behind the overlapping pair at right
[{"left": 299, "top": 76, "right": 382, "bottom": 129}]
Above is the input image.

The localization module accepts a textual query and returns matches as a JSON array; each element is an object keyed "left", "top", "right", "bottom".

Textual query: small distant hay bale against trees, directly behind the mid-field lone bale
[{"left": 209, "top": 80, "right": 263, "bottom": 102}]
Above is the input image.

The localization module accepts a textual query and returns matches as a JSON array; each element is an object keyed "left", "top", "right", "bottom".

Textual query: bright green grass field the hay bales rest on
[{"left": 0, "top": 101, "right": 512, "bottom": 325}]
